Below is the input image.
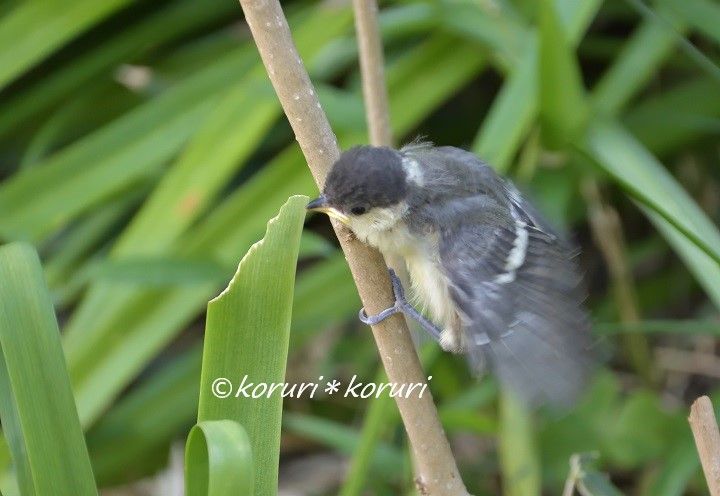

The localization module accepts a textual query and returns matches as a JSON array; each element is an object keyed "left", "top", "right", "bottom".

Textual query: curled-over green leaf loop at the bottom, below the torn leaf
[{"left": 185, "top": 420, "right": 253, "bottom": 496}]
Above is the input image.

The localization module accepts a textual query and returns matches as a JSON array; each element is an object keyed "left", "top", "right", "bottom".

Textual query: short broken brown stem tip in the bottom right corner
[{"left": 688, "top": 396, "right": 720, "bottom": 496}]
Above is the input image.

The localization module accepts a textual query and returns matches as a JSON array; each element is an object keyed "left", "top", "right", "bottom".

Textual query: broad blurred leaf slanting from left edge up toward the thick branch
[{"left": 0, "top": 50, "right": 253, "bottom": 241}]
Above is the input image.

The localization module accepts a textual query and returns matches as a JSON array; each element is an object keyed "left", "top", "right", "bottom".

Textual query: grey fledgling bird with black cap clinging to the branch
[{"left": 308, "top": 143, "right": 593, "bottom": 405}]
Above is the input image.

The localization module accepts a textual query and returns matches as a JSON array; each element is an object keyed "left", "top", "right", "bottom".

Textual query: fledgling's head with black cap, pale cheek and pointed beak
[{"left": 307, "top": 146, "right": 409, "bottom": 240}]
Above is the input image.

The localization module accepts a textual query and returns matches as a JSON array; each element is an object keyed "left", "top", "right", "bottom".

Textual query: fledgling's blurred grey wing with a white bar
[{"left": 440, "top": 192, "right": 592, "bottom": 404}]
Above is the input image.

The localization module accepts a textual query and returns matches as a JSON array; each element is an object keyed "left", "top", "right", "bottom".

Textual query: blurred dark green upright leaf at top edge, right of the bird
[{"left": 538, "top": 0, "right": 588, "bottom": 148}]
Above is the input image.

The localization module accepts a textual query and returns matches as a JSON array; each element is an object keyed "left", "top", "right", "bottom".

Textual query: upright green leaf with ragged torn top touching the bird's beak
[{"left": 198, "top": 196, "right": 308, "bottom": 496}]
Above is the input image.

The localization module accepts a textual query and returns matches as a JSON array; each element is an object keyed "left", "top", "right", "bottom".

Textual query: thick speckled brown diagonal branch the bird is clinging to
[{"left": 240, "top": 0, "right": 467, "bottom": 496}]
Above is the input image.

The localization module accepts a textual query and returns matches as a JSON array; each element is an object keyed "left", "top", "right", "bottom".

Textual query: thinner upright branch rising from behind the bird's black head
[{"left": 353, "top": 0, "right": 392, "bottom": 146}]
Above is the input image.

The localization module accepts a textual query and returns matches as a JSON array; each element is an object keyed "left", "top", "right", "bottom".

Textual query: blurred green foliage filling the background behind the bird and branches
[{"left": 0, "top": 0, "right": 720, "bottom": 496}]
